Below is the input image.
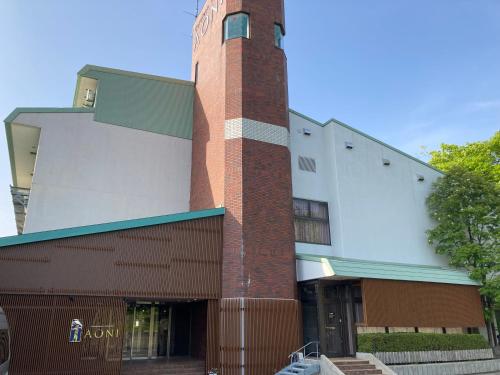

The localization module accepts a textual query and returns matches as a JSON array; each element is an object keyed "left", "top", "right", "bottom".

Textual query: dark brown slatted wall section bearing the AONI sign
[{"left": 0, "top": 295, "right": 126, "bottom": 375}]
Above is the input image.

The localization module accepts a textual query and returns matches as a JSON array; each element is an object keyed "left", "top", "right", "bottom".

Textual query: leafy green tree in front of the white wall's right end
[{"left": 427, "top": 169, "right": 500, "bottom": 318}]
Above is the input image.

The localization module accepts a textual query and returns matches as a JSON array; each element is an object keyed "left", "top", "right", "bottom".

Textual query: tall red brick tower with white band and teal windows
[{"left": 191, "top": 0, "right": 299, "bottom": 375}]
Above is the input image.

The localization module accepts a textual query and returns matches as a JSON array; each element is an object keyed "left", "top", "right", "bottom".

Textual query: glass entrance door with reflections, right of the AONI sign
[{"left": 123, "top": 302, "right": 170, "bottom": 359}]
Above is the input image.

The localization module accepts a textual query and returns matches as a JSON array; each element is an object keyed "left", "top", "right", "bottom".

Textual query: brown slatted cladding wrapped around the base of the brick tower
[{"left": 221, "top": 298, "right": 300, "bottom": 375}]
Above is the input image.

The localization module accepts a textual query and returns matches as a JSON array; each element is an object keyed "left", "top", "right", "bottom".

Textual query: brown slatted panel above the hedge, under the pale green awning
[{"left": 362, "top": 279, "right": 485, "bottom": 328}]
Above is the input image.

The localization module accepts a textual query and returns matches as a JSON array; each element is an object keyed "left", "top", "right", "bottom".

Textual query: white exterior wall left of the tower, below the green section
[{"left": 14, "top": 113, "right": 191, "bottom": 233}]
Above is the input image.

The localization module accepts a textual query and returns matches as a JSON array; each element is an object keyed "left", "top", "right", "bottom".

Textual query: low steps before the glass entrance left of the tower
[{"left": 121, "top": 358, "right": 206, "bottom": 375}]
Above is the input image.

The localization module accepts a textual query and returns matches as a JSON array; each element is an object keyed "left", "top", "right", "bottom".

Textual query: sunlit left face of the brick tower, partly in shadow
[{"left": 190, "top": 0, "right": 226, "bottom": 210}]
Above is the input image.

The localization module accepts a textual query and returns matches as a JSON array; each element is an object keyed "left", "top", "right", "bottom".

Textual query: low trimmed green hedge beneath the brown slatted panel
[{"left": 358, "top": 333, "right": 490, "bottom": 353}]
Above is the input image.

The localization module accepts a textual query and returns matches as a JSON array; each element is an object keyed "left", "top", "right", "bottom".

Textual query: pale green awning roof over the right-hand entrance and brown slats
[{"left": 297, "top": 254, "right": 479, "bottom": 285}]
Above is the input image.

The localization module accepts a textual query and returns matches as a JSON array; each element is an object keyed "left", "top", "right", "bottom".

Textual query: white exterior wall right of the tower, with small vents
[{"left": 290, "top": 113, "right": 447, "bottom": 266}]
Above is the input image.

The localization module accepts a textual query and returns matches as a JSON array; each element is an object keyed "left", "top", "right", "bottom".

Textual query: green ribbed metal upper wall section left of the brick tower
[{"left": 74, "top": 65, "right": 194, "bottom": 139}]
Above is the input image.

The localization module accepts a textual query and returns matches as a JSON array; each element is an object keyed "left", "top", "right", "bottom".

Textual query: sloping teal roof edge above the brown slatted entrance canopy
[{"left": 0, "top": 208, "right": 225, "bottom": 247}]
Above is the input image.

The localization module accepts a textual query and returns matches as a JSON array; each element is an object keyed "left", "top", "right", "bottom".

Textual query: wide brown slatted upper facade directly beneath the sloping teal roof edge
[{"left": 0, "top": 216, "right": 223, "bottom": 299}]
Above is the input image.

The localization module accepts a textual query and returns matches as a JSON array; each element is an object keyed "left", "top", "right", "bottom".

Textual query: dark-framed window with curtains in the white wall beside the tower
[{"left": 293, "top": 199, "right": 330, "bottom": 245}]
